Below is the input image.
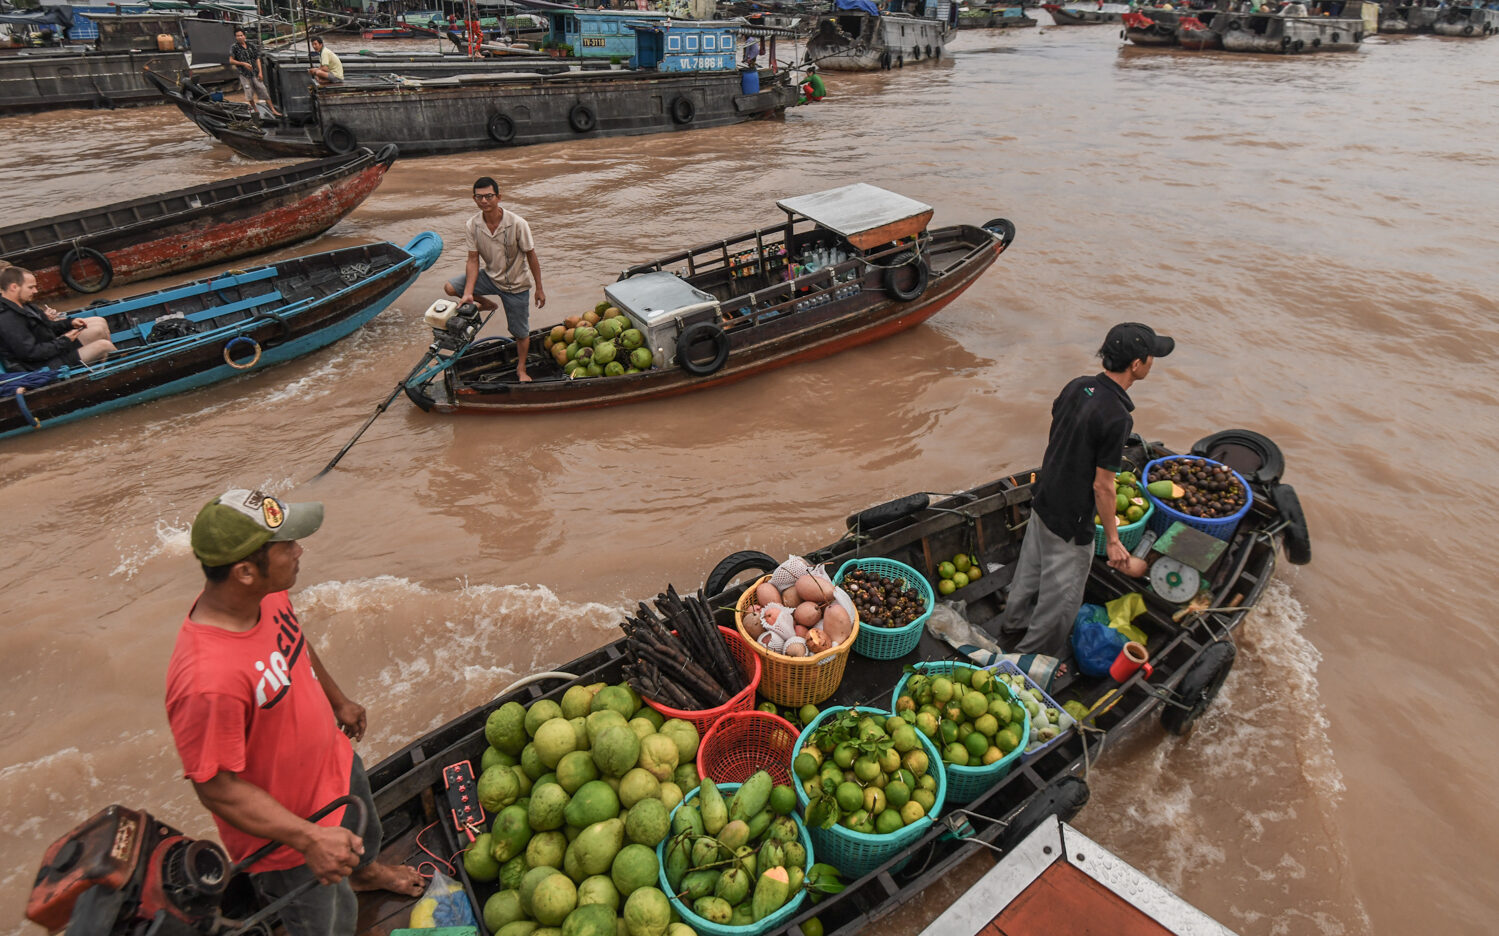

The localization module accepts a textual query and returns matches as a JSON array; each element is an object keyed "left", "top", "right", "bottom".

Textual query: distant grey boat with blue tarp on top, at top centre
[{"left": 806, "top": 0, "right": 956, "bottom": 72}]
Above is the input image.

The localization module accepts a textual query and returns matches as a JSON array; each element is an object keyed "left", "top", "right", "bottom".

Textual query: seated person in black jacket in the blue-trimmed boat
[{"left": 0, "top": 267, "right": 114, "bottom": 371}]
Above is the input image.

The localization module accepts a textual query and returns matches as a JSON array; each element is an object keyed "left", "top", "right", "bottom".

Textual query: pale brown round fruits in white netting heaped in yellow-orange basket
[{"left": 741, "top": 557, "right": 857, "bottom": 657}]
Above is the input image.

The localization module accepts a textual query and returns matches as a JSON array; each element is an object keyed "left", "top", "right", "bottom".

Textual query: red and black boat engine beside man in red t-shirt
[{"left": 25, "top": 806, "right": 232, "bottom": 936}]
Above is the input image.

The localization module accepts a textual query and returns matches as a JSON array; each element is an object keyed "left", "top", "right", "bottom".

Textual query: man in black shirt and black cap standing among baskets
[{"left": 1000, "top": 323, "right": 1175, "bottom": 657}]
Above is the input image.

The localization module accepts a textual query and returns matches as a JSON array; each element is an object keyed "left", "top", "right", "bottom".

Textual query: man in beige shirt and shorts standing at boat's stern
[{"left": 444, "top": 176, "right": 547, "bottom": 384}]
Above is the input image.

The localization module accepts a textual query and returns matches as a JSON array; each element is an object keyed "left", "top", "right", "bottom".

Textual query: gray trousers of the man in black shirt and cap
[{"left": 1000, "top": 513, "right": 1093, "bottom": 657}]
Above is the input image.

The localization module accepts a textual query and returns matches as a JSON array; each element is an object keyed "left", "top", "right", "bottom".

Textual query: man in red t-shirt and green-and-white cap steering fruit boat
[{"left": 166, "top": 491, "right": 423, "bottom": 936}]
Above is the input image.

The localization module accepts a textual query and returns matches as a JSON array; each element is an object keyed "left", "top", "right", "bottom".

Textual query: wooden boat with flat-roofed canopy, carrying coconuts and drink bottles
[{"left": 406, "top": 183, "right": 1015, "bottom": 414}]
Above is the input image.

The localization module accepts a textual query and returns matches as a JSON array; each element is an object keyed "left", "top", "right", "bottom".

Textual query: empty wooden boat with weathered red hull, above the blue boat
[{"left": 0, "top": 147, "right": 396, "bottom": 297}]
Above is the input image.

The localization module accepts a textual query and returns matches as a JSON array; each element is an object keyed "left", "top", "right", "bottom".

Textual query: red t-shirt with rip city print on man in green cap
[{"left": 166, "top": 591, "right": 354, "bottom": 872}]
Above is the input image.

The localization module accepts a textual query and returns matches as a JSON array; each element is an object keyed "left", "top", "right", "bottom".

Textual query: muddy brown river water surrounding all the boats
[{"left": 0, "top": 27, "right": 1499, "bottom": 935}]
